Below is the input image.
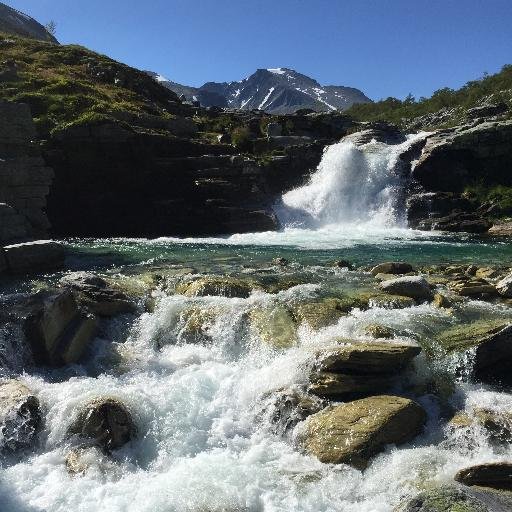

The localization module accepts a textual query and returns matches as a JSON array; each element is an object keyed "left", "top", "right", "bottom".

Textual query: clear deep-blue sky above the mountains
[{"left": 3, "top": 0, "right": 512, "bottom": 99}]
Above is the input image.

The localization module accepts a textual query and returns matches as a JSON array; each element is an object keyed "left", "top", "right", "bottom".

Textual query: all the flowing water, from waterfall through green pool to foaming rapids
[{"left": 0, "top": 137, "right": 512, "bottom": 512}]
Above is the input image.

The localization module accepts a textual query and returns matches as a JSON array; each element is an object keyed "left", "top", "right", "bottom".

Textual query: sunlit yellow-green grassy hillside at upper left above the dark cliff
[{"left": 0, "top": 33, "right": 179, "bottom": 134}]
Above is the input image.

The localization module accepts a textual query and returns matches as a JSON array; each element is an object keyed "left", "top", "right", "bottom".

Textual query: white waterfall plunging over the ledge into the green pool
[{"left": 276, "top": 133, "right": 425, "bottom": 229}]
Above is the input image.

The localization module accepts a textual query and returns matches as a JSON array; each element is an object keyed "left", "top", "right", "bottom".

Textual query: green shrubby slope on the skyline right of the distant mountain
[{"left": 346, "top": 65, "right": 512, "bottom": 128}]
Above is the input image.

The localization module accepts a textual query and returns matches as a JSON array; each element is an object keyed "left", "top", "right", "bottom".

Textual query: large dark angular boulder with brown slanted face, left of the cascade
[{"left": 25, "top": 290, "right": 97, "bottom": 366}]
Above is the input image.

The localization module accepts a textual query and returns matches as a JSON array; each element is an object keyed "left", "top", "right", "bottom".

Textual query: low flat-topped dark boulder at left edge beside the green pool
[{"left": 3, "top": 240, "right": 64, "bottom": 274}]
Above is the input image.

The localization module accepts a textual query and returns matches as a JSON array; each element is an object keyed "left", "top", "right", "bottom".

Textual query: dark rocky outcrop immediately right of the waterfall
[{"left": 407, "top": 119, "right": 512, "bottom": 233}]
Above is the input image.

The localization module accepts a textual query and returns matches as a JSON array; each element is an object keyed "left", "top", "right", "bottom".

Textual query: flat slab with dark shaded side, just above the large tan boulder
[{"left": 315, "top": 340, "right": 421, "bottom": 374}]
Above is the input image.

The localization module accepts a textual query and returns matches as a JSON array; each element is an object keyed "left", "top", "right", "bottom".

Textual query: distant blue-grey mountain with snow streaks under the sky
[{"left": 150, "top": 68, "right": 371, "bottom": 114}]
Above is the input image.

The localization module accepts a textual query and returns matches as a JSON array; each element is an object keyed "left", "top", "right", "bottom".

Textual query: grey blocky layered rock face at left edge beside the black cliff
[{"left": 0, "top": 102, "right": 53, "bottom": 243}]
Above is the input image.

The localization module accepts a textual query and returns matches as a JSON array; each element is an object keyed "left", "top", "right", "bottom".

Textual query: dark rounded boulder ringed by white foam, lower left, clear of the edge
[{"left": 68, "top": 398, "right": 136, "bottom": 452}]
